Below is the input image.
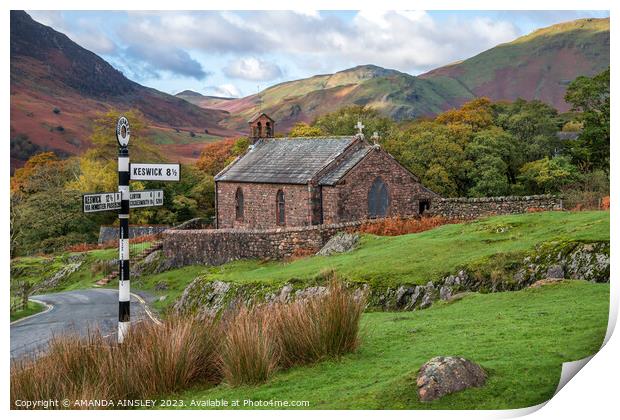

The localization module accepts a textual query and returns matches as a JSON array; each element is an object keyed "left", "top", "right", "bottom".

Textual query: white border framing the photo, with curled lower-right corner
[{"left": 0, "top": 0, "right": 620, "bottom": 420}]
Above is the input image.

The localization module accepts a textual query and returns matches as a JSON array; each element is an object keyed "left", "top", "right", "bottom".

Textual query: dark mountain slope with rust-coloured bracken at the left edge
[{"left": 11, "top": 11, "right": 230, "bottom": 169}]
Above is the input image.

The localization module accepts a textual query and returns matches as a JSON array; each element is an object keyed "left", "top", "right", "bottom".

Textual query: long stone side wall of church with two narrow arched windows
[{"left": 217, "top": 182, "right": 311, "bottom": 229}]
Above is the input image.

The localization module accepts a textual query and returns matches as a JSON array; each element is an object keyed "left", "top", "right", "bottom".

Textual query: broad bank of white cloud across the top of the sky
[{"left": 116, "top": 11, "right": 519, "bottom": 76}]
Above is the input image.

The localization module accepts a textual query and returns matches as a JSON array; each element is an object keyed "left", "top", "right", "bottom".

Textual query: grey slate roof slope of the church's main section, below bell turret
[{"left": 215, "top": 136, "right": 363, "bottom": 184}]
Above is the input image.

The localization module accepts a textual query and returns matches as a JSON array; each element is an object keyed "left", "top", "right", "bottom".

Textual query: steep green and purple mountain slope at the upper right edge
[{"left": 420, "top": 18, "right": 610, "bottom": 111}]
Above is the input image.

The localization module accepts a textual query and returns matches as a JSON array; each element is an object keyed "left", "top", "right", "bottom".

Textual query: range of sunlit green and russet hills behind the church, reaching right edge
[{"left": 209, "top": 19, "right": 610, "bottom": 131}]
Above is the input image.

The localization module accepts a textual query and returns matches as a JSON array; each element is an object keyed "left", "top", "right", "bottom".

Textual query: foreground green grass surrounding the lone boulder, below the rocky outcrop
[{"left": 173, "top": 281, "right": 609, "bottom": 409}]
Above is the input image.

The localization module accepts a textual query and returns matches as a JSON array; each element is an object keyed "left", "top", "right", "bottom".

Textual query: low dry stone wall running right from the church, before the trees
[{"left": 425, "top": 195, "right": 563, "bottom": 219}]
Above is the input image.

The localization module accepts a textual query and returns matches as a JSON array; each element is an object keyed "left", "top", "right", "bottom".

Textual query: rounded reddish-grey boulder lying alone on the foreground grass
[{"left": 416, "top": 356, "right": 487, "bottom": 401}]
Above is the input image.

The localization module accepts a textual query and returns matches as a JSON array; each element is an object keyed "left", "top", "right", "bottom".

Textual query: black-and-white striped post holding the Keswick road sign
[{"left": 118, "top": 146, "right": 130, "bottom": 343}]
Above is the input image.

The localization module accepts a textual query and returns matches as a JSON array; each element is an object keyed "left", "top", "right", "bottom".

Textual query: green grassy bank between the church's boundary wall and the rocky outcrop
[{"left": 196, "top": 212, "right": 609, "bottom": 285}]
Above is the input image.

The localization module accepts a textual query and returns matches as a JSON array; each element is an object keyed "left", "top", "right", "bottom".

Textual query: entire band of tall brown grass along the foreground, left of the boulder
[{"left": 11, "top": 278, "right": 366, "bottom": 408}]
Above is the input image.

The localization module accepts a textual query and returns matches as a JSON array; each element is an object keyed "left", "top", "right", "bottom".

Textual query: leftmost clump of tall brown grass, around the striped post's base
[{"left": 11, "top": 317, "right": 221, "bottom": 408}]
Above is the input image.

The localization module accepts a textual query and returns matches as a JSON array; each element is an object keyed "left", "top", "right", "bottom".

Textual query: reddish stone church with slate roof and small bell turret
[{"left": 215, "top": 113, "right": 438, "bottom": 229}]
